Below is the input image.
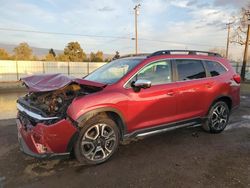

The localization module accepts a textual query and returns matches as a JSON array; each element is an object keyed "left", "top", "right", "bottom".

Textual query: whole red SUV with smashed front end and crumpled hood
[{"left": 17, "top": 50, "right": 240, "bottom": 164}]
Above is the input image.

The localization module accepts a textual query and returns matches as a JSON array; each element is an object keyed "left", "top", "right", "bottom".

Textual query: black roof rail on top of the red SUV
[{"left": 148, "top": 50, "right": 222, "bottom": 57}]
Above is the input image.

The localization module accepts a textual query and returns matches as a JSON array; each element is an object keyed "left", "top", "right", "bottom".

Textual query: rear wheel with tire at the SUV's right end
[{"left": 202, "top": 101, "right": 230, "bottom": 133}]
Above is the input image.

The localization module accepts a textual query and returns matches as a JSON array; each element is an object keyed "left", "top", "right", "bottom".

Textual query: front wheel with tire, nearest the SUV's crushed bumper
[{"left": 74, "top": 116, "right": 120, "bottom": 165}]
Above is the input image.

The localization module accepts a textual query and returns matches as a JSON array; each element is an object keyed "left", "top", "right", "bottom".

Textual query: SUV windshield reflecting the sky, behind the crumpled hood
[{"left": 84, "top": 59, "right": 142, "bottom": 84}]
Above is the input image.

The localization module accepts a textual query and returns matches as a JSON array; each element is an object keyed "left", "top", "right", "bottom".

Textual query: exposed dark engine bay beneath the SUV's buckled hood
[{"left": 17, "top": 83, "right": 101, "bottom": 122}]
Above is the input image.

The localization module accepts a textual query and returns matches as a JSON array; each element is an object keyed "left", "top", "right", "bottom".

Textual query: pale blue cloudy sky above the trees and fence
[{"left": 0, "top": 0, "right": 250, "bottom": 59}]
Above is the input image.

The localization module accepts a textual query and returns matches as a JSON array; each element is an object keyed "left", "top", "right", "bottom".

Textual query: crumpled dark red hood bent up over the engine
[{"left": 20, "top": 74, "right": 106, "bottom": 92}]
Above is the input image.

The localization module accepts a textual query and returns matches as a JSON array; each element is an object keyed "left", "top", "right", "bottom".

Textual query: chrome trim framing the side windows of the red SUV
[{"left": 123, "top": 57, "right": 229, "bottom": 89}]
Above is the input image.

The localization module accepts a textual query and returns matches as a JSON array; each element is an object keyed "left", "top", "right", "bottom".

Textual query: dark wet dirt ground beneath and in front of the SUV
[{"left": 0, "top": 86, "right": 250, "bottom": 188}]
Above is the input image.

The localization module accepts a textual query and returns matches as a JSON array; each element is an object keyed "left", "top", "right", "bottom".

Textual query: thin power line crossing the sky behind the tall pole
[{"left": 0, "top": 28, "right": 224, "bottom": 47}]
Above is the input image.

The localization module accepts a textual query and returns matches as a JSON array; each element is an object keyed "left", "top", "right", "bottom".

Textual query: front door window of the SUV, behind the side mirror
[{"left": 126, "top": 61, "right": 172, "bottom": 88}]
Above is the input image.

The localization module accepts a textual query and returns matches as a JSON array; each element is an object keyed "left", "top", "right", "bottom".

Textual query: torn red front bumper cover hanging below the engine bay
[{"left": 16, "top": 108, "right": 78, "bottom": 158}]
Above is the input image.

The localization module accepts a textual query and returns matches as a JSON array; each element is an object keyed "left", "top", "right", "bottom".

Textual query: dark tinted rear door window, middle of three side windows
[{"left": 175, "top": 59, "right": 206, "bottom": 81}]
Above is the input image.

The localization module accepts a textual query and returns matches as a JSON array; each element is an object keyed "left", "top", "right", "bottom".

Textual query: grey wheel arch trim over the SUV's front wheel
[{"left": 76, "top": 107, "right": 127, "bottom": 139}]
